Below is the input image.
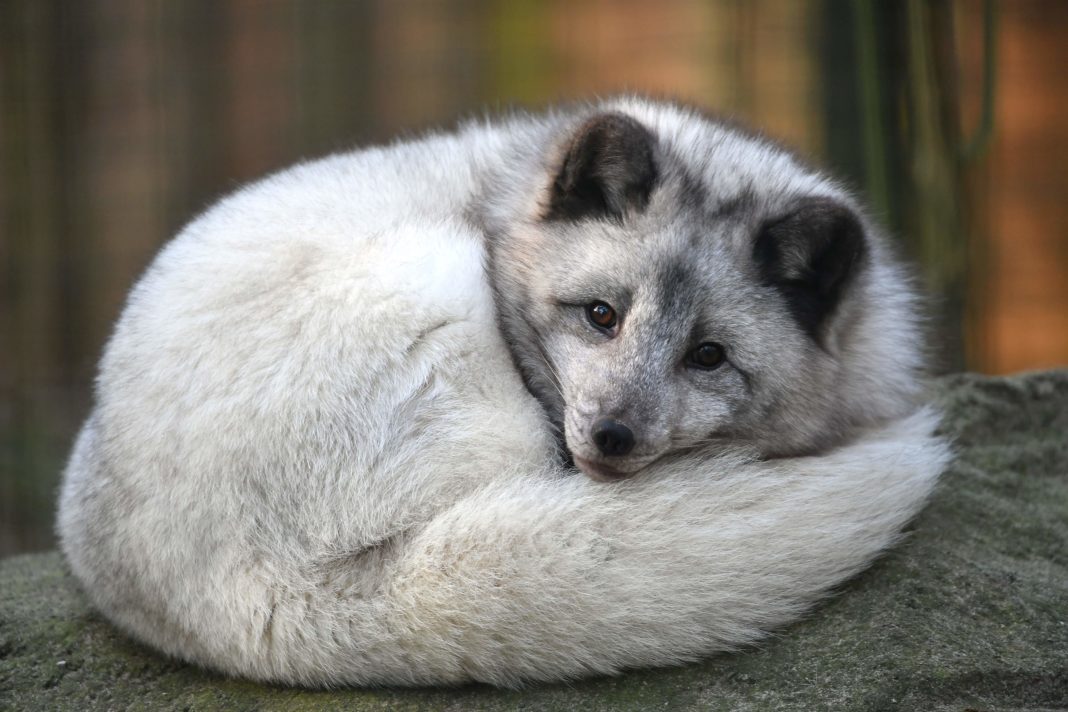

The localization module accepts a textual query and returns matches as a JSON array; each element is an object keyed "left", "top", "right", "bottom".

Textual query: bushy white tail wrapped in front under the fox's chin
[{"left": 229, "top": 410, "right": 949, "bottom": 686}]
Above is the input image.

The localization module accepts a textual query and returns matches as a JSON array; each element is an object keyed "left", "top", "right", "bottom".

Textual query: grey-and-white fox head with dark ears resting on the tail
[{"left": 489, "top": 100, "right": 923, "bottom": 479}]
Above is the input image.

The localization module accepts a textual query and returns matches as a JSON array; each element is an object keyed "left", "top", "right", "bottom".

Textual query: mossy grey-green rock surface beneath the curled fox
[{"left": 0, "top": 371, "right": 1068, "bottom": 711}]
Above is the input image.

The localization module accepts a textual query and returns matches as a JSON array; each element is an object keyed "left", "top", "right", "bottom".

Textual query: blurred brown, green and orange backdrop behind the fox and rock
[{"left": 0, "top": 0, "right": 1068, "bottom": 555}]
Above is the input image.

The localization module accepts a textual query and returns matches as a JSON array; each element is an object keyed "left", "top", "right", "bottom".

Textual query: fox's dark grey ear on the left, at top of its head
[{"left": 546, "top": 113, "right": 657, "bottom": 220}]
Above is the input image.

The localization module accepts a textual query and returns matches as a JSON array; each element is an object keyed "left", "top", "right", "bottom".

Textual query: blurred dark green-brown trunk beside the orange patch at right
[{"left": 824, "top": 0, "right": 983, "bottom": 370}]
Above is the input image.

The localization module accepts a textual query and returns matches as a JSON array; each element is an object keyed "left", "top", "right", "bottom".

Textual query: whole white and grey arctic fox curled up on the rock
[{"left": 58, "top": 97, "right": 947, "bottom": 685}]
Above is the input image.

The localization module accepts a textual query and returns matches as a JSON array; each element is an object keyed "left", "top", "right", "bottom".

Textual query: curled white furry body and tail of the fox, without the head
[{"left": 59, "top": 100, "right": 947, "bottom": 685}]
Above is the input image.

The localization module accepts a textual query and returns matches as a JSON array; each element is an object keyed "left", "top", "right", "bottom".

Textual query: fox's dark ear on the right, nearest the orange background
[{"left": 753, "top": 197, "right": 868, "bottom": 341}]
